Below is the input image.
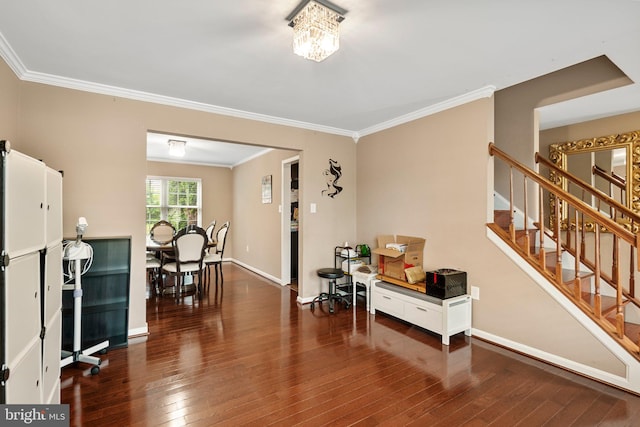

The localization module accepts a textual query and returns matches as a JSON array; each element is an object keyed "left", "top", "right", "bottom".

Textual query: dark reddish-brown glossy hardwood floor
[{"left": 61, "top": 263, "right": 640, "bottom": 427}]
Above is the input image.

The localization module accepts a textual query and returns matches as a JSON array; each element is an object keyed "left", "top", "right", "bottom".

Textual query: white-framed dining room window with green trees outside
[{"left": 147, "top": 176, "right": 202, "bottom": 233}]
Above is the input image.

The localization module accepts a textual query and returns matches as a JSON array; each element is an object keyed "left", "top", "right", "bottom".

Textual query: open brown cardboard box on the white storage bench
[{"left": 371, "top": 235, "right": 425, "bottom": 280}]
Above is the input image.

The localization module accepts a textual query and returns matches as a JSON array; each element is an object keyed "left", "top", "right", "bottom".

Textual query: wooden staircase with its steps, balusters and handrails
[{"left": 487, "top": 144, "right": 640, "bottom": 360}]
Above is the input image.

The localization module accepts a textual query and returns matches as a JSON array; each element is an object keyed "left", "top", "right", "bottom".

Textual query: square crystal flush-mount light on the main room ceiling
[{"left": 287, "top": 0, "right": 347, "bottom": 62}]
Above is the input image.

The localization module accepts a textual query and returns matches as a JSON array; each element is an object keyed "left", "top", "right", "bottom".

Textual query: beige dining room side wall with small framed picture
[{"left": 231, "top": 150, "right": 298, "bottom": 278}]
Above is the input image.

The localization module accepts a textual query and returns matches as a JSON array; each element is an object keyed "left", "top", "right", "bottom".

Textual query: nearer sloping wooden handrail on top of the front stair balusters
[{"left": 489, "top": 142, "right": 640, "bottom": 247}]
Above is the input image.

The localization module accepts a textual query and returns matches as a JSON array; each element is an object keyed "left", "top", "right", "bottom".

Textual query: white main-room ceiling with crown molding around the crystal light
[{"left": 0, "top": 0, "right": 640, "bottom": 164}]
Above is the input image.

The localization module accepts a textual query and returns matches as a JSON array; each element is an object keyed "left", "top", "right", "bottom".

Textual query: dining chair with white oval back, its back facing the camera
[{"left": 162, "top": 226, "right": 207, "bottom": 298}]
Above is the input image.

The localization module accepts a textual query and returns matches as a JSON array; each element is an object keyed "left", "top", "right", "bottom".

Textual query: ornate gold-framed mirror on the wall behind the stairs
[{"left": 549, "top": 130, "right": 640, "bottom": 231}]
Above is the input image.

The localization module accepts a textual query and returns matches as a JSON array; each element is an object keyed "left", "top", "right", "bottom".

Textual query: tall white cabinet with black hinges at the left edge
[{"left": 0, "top": 141, "right": 62, "bottom": 404}]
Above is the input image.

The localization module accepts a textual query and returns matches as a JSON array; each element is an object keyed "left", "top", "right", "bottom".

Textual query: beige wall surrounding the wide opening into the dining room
[{"left": 0, "top": 56, "right": 355, "bottom": 330}]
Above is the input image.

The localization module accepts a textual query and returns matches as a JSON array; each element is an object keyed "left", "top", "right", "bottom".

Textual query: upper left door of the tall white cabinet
[{"left": 4, "top": 150, "right": 46, "bottom": 258}]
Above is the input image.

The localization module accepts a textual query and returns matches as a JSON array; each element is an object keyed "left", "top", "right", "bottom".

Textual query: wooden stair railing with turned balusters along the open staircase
[{"left": 487, "top": 143, "right": 640, "bottom": 359}]
